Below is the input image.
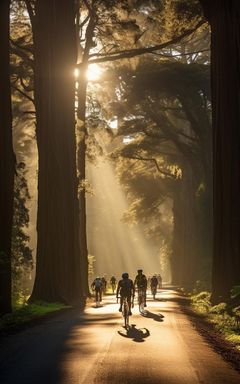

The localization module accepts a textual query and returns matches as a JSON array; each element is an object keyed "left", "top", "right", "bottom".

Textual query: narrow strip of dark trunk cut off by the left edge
[{"left": 0, "top": 0, "right": 15, "bottom": 314}]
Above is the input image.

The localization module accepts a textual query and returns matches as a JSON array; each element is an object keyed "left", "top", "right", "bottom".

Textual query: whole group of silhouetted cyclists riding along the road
[{"left": 91, "top": 269, "right": 162, "bottom": 315}]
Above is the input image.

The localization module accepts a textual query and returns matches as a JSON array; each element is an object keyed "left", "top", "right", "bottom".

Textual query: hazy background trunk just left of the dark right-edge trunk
[{"left": 179, "top": 94, "right": 213, "bottom": 283}]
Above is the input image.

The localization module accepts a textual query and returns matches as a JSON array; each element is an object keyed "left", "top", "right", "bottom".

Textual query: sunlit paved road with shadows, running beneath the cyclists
[{"left": 0, "top": 290, "right": 240, "bottom": 384}]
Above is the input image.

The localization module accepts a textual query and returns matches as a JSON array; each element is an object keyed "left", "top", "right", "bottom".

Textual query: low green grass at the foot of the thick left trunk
[{"left": 0, "top": 297, "right": 71, "bottom": 331}]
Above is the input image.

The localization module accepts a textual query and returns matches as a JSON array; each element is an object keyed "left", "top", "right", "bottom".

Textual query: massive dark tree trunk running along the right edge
[{"left": 201, "top": 0, "right": 240, "bottom": 302}]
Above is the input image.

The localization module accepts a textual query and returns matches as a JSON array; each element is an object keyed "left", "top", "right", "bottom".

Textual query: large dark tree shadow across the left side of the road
[{"left": 0, "top": 309, "right": 118, "bottom": 384}]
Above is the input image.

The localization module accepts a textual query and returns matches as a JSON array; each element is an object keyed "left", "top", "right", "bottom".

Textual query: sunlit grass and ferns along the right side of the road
[{"left": 191, "top": 291, "right": 240, "bottom": 351}]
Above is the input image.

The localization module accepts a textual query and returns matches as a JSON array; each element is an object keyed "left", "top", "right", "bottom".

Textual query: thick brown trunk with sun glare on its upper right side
[{"left": 31, "top": 0, "right": 82, "bottom": 304}]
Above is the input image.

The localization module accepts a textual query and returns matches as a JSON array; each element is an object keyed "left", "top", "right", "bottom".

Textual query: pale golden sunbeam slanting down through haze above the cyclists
[{"left": 87, "top": 161, "right": 160, "bottom": 275}]
